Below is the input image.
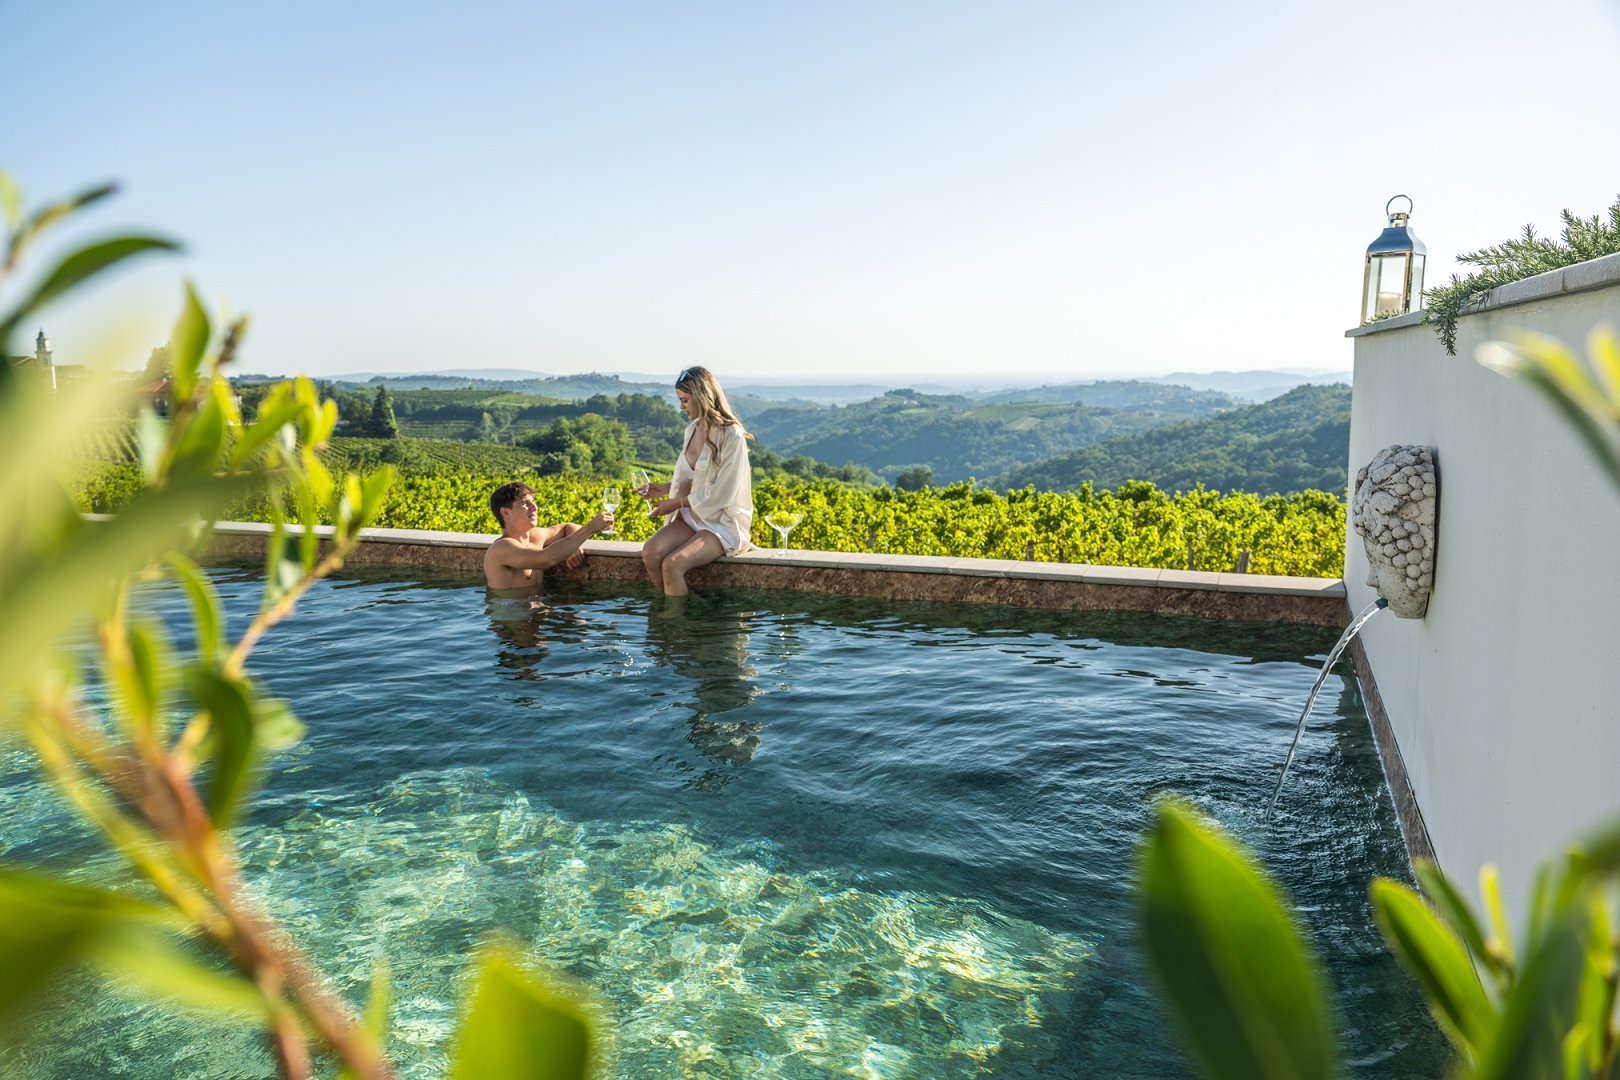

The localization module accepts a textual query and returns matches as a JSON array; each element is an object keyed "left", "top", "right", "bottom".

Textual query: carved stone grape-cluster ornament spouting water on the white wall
[{"left": 1351, "top": 445, "right": 1440, "bottom": 619}]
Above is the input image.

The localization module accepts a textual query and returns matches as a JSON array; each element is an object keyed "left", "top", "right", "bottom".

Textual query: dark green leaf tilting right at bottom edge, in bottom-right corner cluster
[{"left": 1476, "top": 908, "right": 1586, "bottom": 1080}]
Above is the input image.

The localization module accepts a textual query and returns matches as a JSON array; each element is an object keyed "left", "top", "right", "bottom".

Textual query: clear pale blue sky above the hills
[{"left": 9, "top": 0, "right": 1620, "bottom": 382}]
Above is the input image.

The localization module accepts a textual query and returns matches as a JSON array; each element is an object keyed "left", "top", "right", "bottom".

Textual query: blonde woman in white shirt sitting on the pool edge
[{"left": 642, "top": 368, "right": 753, "bottom": 596}]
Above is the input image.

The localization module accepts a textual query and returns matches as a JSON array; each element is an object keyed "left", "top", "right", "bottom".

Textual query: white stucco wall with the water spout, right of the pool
[{"left": 1345, "top": 256, "right": 1620, "bottom": 923}]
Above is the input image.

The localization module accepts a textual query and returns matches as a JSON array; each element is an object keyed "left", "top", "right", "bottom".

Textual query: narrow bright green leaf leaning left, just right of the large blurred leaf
[{"left": 1371, "top": 878, "right": 1497, "bottom": 1059}]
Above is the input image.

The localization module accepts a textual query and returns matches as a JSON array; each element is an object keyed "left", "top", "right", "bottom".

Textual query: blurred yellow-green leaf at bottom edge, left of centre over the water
[{"left": 450, "top": 947, "right": 591, "bottom": 1080}]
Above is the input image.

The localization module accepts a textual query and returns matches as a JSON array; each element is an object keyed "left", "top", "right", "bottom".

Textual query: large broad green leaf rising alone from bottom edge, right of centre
[{"left": 1139, "top": 803, "right": 1338, "bottom": 1080}]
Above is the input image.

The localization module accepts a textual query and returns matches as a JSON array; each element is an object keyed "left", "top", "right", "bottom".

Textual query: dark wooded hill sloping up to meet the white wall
[{"left": 996, "top": 385, "right": 1349, "bottom": 495}]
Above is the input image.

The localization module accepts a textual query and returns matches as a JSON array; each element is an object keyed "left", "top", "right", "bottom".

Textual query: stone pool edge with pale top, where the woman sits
[{"left": 211, "top": 521, "right": 1349, "bottom": 627}]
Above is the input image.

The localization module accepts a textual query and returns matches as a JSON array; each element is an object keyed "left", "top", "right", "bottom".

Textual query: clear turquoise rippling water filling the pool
[{"left": 0, "top": 568, "right": 1445, "bottom": 1078}]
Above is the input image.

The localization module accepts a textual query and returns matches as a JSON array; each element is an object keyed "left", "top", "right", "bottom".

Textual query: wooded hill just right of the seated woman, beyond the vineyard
[{"left": 745, "top": 389, "right": 1226, "bottom": 484}]
